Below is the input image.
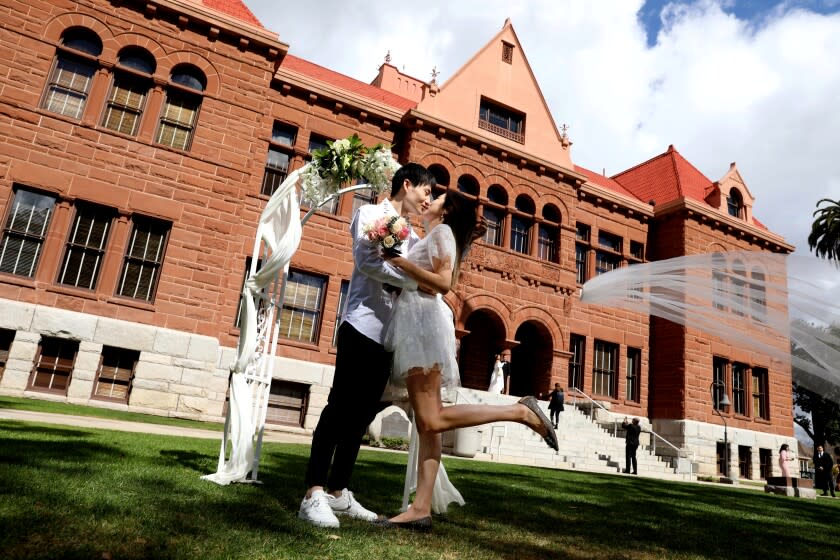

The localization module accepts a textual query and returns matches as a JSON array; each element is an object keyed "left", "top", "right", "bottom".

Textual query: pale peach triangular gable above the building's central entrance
[{"left": 417, "top": 20, "right": 573, "bottom": 169}]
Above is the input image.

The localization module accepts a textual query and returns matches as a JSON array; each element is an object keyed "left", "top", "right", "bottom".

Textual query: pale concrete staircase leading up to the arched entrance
[{"left": 444, "top": 388, "right": 697, "bottom": 480}]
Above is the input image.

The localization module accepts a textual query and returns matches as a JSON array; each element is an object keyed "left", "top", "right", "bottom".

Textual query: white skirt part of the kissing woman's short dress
[{"left": 385, "top": 290, "right": 461, "bottom": 388}]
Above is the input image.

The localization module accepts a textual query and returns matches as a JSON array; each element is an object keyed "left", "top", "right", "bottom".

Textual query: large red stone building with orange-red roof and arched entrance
[{"left": 0, "top": 0, "right": 793, "bottom": 478}]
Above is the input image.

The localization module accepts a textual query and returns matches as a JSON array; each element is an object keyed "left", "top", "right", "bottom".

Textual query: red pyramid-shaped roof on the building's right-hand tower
[{"left": 612, "top": 146, "right": 712, "bottom": 204}]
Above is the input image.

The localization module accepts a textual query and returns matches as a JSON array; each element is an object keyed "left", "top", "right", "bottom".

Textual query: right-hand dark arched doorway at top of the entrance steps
[{"left": 510, "top": 321, "right": 554, "bottom": 397}]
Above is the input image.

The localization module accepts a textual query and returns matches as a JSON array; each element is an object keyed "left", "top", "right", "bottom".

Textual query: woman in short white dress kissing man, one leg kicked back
[{"left": 378, "top": 191, "right": 557, "bottom": 531}]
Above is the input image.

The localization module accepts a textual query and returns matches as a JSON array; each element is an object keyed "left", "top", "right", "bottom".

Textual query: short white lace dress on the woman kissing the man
[{"left": 385, "top": 224, "right": 460, "bottom": 388}]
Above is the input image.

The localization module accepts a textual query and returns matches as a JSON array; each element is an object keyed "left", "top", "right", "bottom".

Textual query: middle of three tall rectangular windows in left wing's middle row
[{"left": 58, "top": 204, "right": 114, "bottom": 290}]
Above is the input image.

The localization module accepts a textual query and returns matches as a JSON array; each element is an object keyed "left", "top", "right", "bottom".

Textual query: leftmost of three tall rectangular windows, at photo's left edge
[{"left": 0, "top": 189, "right": 55, "bottom": 278}]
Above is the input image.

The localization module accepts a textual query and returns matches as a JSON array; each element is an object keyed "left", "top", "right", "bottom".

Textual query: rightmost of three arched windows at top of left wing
[{"left": 156, "top": 64, "right": 207, "bottom": 150}]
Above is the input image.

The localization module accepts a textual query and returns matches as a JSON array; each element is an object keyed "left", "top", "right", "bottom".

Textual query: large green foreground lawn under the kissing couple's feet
[{"left": 0, "top": 421, "right": 840, "bottom": 560}]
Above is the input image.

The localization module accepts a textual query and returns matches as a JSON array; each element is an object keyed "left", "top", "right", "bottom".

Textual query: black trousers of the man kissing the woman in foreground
[{"left": 306, "top": 321, "right": 391, "bottom": 491}]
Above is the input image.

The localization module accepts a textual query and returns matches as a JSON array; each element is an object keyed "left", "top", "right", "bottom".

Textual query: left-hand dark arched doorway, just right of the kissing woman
[{"left": 458, "top": 309, "right": 505, "bottom": 391}]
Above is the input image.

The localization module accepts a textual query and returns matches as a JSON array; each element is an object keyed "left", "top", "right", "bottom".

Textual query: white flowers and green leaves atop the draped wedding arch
[{"left": 300, "top": 134, "right": 400, "bottom": 207}]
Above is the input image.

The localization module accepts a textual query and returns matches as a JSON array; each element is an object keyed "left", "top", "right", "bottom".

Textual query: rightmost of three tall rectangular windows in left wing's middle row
[{"left": 117, "top": 216, "right": 170, "bottom": 301}]
